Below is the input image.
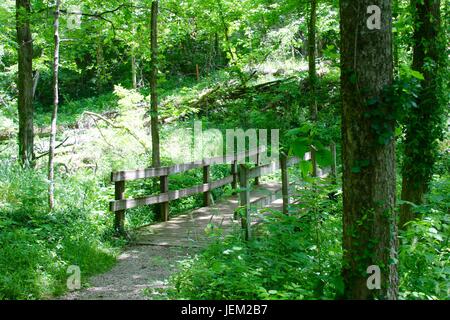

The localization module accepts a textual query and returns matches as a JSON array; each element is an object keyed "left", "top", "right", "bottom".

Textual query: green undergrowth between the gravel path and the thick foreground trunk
[{"left": 169, "top": 180, "right": 342, "bottom": 300}]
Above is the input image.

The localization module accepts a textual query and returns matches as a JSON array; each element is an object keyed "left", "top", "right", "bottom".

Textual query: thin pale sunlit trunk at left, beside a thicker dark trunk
[{"left": 48, "top": 0, "right": 61, "bottom": 210}]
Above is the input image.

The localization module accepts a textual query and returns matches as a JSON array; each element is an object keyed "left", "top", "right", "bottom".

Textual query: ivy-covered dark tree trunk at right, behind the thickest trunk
[{"left": 400, "top": 0, "right": 445, "bottom": 227}]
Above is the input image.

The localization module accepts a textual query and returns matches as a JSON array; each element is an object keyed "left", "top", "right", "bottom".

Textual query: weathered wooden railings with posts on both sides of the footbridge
[{"left": 110, "top": 148, "right": 300, "bottom": 239}]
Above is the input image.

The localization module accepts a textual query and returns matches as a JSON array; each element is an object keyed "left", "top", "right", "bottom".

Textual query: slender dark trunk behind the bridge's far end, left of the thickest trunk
[{"left": 308, "top": 0, "right": 317, "bottom": 177}]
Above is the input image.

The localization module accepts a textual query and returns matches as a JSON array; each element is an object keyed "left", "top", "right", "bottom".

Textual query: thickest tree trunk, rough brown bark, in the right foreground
[{"left": 340, "top": 0, "right": 398, "bottom": 299}]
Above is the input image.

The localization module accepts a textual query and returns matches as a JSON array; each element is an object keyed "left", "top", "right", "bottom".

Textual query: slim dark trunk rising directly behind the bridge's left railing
[{"left": 150, "top": 0, "right": 161, "bottom": 167}]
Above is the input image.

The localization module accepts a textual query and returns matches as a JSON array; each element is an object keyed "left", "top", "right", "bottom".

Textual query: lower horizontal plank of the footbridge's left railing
[{"left": 110, "top": 176, "right": 233, "bottom": 212}]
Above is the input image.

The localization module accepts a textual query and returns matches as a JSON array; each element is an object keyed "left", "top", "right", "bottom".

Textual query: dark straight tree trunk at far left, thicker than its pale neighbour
[{"left": 16, "top": 0, "right": 34, "bottom": 167}]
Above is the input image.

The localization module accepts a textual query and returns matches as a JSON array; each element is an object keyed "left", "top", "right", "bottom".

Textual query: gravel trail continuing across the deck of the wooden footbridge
[{"left": 62, "top": 183, "right": 282, "bottom": 300}]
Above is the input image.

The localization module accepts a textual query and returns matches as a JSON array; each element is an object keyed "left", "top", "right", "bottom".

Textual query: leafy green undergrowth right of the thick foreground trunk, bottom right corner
[{"left": 399, "top": 173, "right": 450, "bottom": 300}]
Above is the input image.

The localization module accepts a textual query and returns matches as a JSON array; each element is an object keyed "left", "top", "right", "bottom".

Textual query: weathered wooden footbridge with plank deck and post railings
[{"left": 110, "top": 147, "right": 334, "bottom": 245}]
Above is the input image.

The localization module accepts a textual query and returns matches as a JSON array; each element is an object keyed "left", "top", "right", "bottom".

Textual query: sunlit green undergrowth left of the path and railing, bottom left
[{"left": 0, "top": 162, "right": 117, "bottom": 299}]
